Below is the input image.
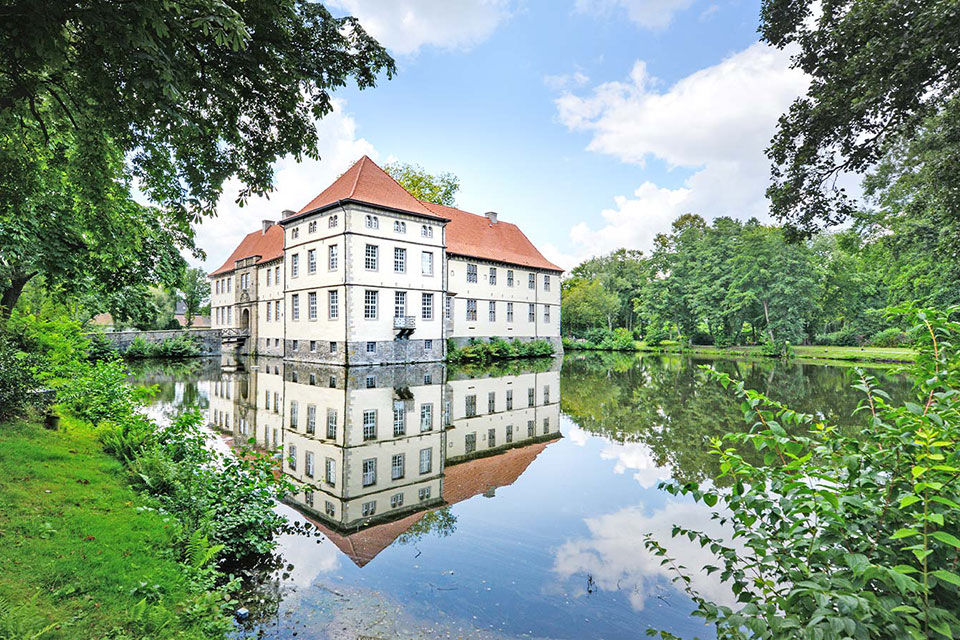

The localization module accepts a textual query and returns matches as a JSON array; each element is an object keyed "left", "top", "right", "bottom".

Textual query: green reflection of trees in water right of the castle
[{"left": 560, "top": 355, "right": 910, "bottom": 481}]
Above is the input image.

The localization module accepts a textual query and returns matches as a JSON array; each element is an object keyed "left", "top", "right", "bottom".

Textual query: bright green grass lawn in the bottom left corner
[{"left": 0, "top": 412, "right": 229, "bottom": 640}]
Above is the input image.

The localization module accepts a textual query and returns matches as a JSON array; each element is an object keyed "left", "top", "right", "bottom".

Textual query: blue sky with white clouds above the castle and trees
[{"left": 193, "top": 0, "right": 807, "bottom": 271}]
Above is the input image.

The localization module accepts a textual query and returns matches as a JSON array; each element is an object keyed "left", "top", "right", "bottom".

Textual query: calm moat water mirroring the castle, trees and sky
[{"left": 131, "top": 355, "right": 909, "bottom": 640}]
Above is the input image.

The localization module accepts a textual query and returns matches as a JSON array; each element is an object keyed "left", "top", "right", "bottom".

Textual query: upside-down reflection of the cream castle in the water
[{"left": 209, "top": 358, "right": 561, "bottom": 566}]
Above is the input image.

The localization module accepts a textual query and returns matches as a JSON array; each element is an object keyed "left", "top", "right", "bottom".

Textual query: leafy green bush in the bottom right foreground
[{"left": 646, "top": 307, "right": 960, "bottom": 640}]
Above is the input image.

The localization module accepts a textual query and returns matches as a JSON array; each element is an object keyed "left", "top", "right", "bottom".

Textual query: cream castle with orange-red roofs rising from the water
[{"left": 209, "top": 156, "right": 562, "bottom": 365}]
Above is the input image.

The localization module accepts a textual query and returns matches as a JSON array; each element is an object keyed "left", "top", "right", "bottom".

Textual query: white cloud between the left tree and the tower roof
[{"left": 196, "top": 101, "right": 377, "bottom": 272}]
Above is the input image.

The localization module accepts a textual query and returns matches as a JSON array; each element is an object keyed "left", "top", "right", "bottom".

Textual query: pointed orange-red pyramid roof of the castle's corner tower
[{"left": 285, "top": 156, "right": 442, "bottom": 221}]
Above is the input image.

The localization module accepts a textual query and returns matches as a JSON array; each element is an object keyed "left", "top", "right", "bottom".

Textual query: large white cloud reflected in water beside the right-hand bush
[{"left": 553, "top": 502, "right": 736, "bottom": 611}]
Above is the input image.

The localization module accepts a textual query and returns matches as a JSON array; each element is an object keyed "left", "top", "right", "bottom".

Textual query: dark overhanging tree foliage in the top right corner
[{"left": 761, "top": 0, "right": 960, "bottom": 235}]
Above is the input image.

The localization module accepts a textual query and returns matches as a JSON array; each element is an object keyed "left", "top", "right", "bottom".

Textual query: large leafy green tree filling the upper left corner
[{"left": 0, "top": 0, "right": 394, "bottom": 315}]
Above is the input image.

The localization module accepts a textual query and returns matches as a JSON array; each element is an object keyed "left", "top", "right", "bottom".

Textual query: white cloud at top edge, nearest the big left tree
[{"left": 330, "top": 0, "right": 512, "bottom": 55}]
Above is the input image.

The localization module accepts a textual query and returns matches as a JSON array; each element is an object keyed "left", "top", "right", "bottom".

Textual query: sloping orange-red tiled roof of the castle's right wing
[{"left": 423, "top": 202, "right": 563, "bottom": 271}]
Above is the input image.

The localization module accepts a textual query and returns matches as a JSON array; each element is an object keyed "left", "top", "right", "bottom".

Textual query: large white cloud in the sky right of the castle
[{"left": 556, "top": 42, "right": 807, "bottom": 266}]
